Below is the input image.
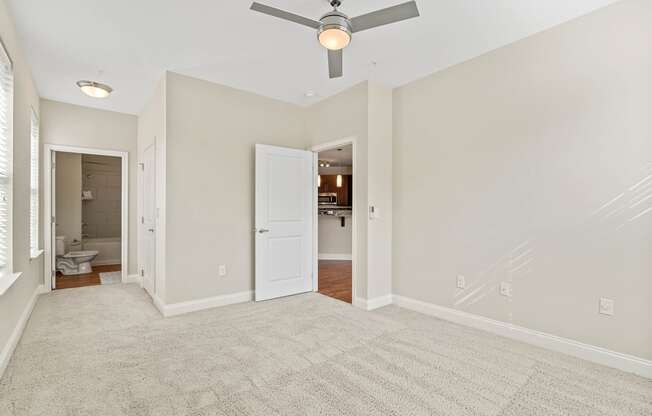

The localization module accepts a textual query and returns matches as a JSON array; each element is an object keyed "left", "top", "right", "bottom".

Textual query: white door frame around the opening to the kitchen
[{"left": 310, "top": 136, "right": 359, "bottom": 302}]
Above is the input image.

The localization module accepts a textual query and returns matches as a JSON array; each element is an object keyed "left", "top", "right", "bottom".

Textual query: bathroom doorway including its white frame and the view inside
[{"left": 44, "top": 144, "right": 128, "bottom": 290}]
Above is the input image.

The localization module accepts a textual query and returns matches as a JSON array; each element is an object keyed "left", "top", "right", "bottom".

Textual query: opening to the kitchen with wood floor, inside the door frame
[{"left": 317, "top": 143, "right": 354, "bottom": 303}]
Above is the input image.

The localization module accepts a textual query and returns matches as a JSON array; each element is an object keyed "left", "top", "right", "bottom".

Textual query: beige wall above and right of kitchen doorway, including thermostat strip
[{"left": 306, "top": 82, "right": 392, "bottom": 300}]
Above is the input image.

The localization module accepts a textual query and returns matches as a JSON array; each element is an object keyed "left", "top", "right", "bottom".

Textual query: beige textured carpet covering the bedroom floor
[{"left": 0, "top": 285, "right": 652, "bottom": 416}]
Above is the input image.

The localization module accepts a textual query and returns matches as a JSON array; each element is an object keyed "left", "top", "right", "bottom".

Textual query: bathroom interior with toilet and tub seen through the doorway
[{"left": 54, "top": 152, "right": 122, "bottom": 289}]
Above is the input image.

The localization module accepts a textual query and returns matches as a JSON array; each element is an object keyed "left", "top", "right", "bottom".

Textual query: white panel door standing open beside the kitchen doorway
[{"left": 254, "top": 144, "right": 314, "bottom": 301}]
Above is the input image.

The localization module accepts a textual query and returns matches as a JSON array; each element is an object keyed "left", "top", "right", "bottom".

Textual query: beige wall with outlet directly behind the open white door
[{"left": 164, "top": 73, "right": 307, "bottom": 303}]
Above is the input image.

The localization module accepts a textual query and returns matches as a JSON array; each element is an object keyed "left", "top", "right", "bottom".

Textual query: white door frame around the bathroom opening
[{"left": 43, "top": 143, "right": 129, "bottom": 292}]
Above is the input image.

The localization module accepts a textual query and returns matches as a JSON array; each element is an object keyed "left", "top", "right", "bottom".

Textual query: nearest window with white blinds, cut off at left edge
[{"left": 0, "top": 39, "right": 14, "bottom": 282}]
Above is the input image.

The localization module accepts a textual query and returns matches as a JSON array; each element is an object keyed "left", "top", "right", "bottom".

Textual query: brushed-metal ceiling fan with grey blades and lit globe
[{"left": 251, "top": 0, "right": 419, "bottom": 78}]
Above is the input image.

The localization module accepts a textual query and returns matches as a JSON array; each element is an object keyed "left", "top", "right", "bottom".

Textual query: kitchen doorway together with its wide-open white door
[{"left": 253, "top": 138, "right": 357, "bottom": 303}]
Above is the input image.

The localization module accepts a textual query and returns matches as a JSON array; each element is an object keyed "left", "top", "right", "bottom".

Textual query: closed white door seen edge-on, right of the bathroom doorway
[{"left": 140, "top": 145, "right": 156, "bottom": 297}]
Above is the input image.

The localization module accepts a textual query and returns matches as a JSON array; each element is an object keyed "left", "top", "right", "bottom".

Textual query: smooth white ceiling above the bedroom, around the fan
[{"left": 6, "top": 0, "right": 616, "bottom": 114}]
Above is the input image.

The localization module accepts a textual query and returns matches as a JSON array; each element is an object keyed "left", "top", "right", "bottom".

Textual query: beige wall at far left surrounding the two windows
[{"left": 0, "top": 1, "right": 43, "bottom": 373}]
